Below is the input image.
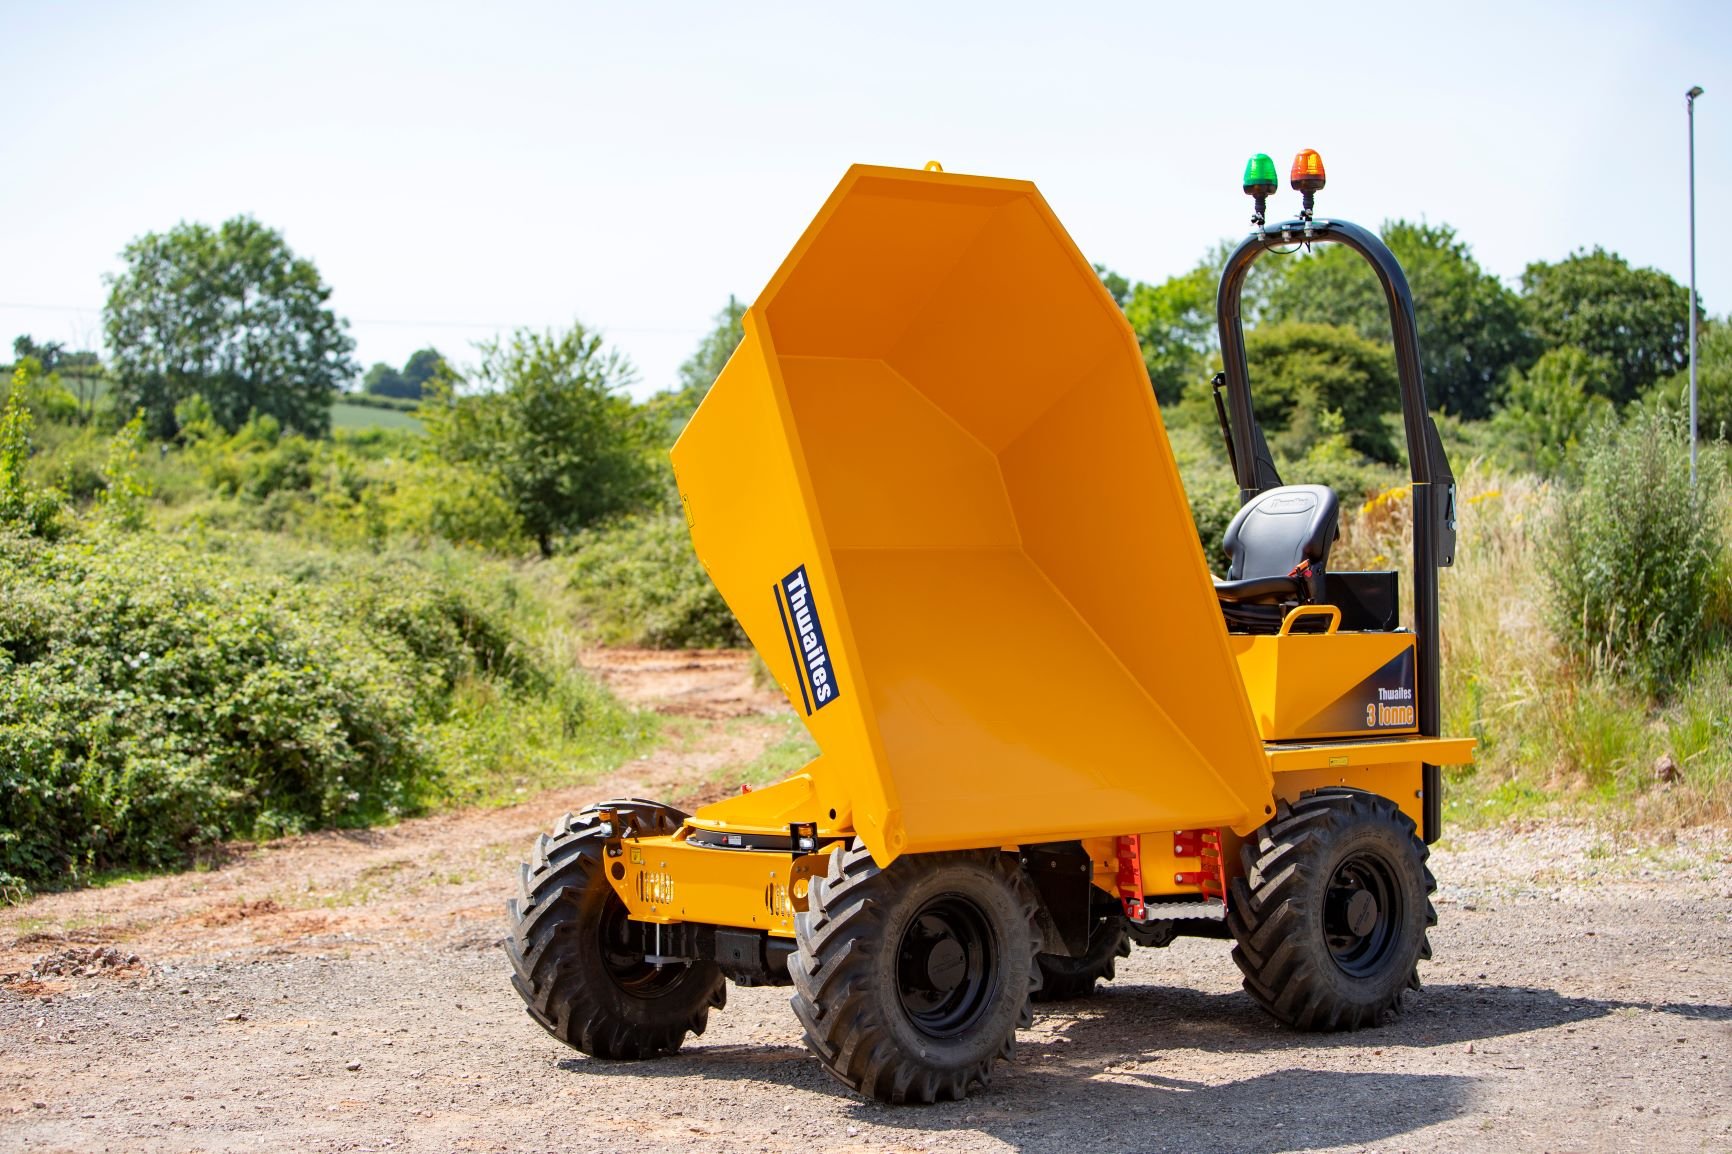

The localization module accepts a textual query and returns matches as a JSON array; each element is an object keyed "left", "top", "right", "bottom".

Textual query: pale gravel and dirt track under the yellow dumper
[{"left": 0, "top": 657, "right": 1732, "bottom": 1154}]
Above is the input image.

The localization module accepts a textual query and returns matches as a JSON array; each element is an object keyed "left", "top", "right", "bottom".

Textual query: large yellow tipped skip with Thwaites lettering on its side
[{"left": 674, "top": 166, "right": 1271, "bottom": 863}]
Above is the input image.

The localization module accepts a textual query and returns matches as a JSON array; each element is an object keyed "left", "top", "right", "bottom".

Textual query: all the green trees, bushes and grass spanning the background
[{"left": 0, "top": 218, "right": 1732, "bottom": 891}]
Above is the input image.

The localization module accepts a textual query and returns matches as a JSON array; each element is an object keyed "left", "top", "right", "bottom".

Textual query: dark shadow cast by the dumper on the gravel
[{"left": 559, "top": 984, "right": 1732, "bottom": 1154}]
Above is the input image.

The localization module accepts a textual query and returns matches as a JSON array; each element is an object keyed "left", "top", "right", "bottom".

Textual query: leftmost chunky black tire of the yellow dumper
[{"left": 506, "top": 801, "right": 727, "bottom": 1059}]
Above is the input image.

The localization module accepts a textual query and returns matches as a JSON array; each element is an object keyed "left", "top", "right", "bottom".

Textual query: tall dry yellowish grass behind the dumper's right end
[{"left": 1330, "top": 461, "right": 1732, "bottom": 827}]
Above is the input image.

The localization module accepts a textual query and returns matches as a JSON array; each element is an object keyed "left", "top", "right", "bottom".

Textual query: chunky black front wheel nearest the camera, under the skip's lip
[{"left": 788, "top": 842, "right": 1039, "bottom": 1102}]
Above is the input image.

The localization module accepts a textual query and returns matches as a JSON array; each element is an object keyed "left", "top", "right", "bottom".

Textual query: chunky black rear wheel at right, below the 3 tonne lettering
[{"left": 1228, "top": 788, "right": 1438, "bottom": 1031}]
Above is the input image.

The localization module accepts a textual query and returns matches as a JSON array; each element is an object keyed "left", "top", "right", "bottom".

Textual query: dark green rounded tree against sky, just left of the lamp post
[{"left": 1521, "top": 248, "right": 1690, "bottom": 404}]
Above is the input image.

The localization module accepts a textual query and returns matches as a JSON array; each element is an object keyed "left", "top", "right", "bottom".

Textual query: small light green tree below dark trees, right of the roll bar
[{"left": 1491, "top": 348, "right": 1618, "bottom": 475}]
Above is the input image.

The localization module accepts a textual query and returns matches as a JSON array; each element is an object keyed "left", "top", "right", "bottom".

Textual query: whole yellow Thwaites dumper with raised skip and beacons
[{"left": 507, "top": 152, "right": 1472, "bottom": 1102}]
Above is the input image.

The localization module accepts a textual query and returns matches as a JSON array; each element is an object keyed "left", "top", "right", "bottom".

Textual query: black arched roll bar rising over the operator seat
[{"left": 1214, "top": 220, "right": 1455, "bottom": 842}]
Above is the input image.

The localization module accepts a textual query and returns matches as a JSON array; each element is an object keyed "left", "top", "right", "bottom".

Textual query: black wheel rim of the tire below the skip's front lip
[{"left": 895, "top": 894, "right": 999, "bottom": 1038}]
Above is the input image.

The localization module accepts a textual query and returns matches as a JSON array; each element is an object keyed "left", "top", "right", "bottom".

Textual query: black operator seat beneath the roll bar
[{"left": 1214, "top": 485, "right": 1341, "bottom": 624}]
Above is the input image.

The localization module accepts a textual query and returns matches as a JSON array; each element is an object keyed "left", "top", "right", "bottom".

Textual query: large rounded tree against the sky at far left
[{"left": 104, "top": 217, "right": 355, "bottom": 437}]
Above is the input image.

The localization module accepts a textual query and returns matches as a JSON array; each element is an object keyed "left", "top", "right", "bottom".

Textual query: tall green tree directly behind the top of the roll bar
[{"left": 1270, "top": 220, "right": 1536, "bottom": 419}]
